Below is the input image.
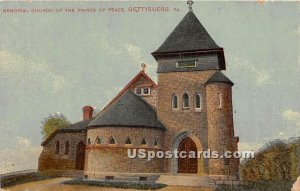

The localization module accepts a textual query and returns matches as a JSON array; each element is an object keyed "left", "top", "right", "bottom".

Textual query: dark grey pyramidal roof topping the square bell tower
[{"left": 152, "top": 11, "right": 220, "bottom": 55}]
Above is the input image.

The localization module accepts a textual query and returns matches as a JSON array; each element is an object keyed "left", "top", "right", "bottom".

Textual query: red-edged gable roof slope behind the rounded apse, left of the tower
[{"left": 103, "top": 70, "right": 157, "bottom": 110}]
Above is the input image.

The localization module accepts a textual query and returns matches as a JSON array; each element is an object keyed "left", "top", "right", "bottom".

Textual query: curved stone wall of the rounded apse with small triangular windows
[{"left": 85, "top": 127, "right": 164, "bottom": 175}]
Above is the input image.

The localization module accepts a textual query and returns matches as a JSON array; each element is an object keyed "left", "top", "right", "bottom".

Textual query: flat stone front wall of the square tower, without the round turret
[{"left": 157, "top": 71, "right": 214, "bottom": 174}]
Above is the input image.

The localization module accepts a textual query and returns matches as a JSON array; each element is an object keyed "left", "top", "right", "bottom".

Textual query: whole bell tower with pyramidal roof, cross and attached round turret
[{"left": 152, "top": 0, "right": 238, "bottom": 178}]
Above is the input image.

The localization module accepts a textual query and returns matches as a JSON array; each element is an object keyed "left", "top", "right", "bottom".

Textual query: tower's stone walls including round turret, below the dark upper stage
[{"left": 157, "top": 70, "right": 239, "bottom": 175}]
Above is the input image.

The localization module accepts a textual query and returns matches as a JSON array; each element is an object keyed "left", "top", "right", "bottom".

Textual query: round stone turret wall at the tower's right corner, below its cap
[{"left": 206, "top": 83, "right": 238, "bottom": 175}]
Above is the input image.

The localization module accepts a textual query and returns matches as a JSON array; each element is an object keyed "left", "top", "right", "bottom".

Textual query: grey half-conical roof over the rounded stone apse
[{"left": 89, "top": 90, "right": 165, "bottom": 129}]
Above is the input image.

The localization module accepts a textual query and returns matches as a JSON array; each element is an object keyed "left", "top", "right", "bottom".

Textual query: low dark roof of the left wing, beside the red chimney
[{"left": 41, "top": 117, "right": 95, "bottom": 146}]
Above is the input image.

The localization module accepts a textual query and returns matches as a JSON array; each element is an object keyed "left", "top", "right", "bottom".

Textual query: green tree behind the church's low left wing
[{"left": 41, "top": 112, "right": 71, "bottom": 140}]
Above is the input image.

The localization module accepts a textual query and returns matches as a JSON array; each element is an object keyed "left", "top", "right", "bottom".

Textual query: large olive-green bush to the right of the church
[{"left": 241, "top": 140, "right": 299, "bottom": 182}]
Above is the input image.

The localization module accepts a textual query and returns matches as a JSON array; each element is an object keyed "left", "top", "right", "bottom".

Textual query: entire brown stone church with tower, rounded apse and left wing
[{"left": 39, "top": 1, "right": 239, "bottom": 184}]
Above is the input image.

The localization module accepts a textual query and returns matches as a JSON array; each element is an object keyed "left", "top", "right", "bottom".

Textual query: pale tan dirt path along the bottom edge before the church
[{"left": 4, "top": 178, "right": 213, "bottom": 191}]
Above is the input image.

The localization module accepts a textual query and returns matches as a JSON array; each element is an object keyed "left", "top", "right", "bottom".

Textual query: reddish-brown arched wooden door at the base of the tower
[{"left": 178, "top": 137, "right": 198, "bottom": 174}]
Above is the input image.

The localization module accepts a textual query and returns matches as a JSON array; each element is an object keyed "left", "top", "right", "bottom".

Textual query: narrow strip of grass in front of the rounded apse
[{"left": 63, "top": 179, "right": 167, "bottom": 190}]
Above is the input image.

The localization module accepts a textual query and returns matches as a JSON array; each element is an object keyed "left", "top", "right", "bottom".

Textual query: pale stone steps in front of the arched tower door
[{"left": 156, "top": 174, "right": 216, "bottom": 188}]
